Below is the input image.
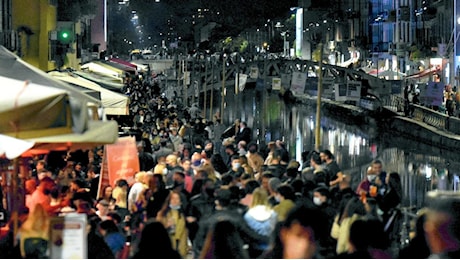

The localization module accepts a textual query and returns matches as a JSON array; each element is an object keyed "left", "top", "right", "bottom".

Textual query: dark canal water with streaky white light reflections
[{"left": 207, "top": 88, "right": 460, "bottom": 208}]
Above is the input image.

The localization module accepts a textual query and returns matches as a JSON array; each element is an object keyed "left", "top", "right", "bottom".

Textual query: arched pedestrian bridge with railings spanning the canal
[{"left": 144, "top": 57, "right": 401, "bottom": 98}]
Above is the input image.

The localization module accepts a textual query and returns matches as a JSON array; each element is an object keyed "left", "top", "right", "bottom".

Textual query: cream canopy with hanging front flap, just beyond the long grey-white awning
[{"left": 48, "top": 71, "right": 129, "bottom": 115}]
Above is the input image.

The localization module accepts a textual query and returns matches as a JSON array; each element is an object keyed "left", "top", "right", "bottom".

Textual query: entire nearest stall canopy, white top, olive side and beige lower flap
[{"left": 0, "top": 77, "right": 118, "bottom": 154}]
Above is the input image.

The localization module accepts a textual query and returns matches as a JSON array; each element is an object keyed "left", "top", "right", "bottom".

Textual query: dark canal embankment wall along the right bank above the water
[{"left": 296, "top": 92, "right": 460, "bottom": 151}]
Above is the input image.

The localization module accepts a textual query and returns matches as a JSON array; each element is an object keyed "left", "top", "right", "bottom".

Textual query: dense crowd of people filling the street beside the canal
[{"left": 0, "top": 70, "right": 460, "bottom": 258}]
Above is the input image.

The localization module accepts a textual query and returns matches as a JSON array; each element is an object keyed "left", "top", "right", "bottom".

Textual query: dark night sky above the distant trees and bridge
[{"left": 126, "top": 0, "right": 297, "bottom": 44}]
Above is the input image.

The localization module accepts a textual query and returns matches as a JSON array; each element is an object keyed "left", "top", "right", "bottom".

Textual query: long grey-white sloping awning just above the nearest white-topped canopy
[{"left": 0, "top": 46, "right": 100, "bottom": 105}]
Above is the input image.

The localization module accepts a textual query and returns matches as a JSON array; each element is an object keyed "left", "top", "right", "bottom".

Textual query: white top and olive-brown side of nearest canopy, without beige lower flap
[{"left": 0, "top": 77, "right": 74, "bottom": 139}]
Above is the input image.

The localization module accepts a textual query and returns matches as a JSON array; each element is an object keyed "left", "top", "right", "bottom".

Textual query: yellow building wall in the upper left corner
[{"left": 12, "top": 0, "right": 56, "bottom": 71}]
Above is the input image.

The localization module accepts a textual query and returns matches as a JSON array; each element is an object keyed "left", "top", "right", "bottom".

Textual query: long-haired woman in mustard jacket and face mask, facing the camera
[{"left": 156, "top": 191, "right": 188, "bottom": 258}]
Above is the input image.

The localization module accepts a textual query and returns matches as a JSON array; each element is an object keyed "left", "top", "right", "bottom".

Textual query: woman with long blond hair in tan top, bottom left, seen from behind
[{"left": 19, "top": 204, "right": 50, "bottom": 258}]
